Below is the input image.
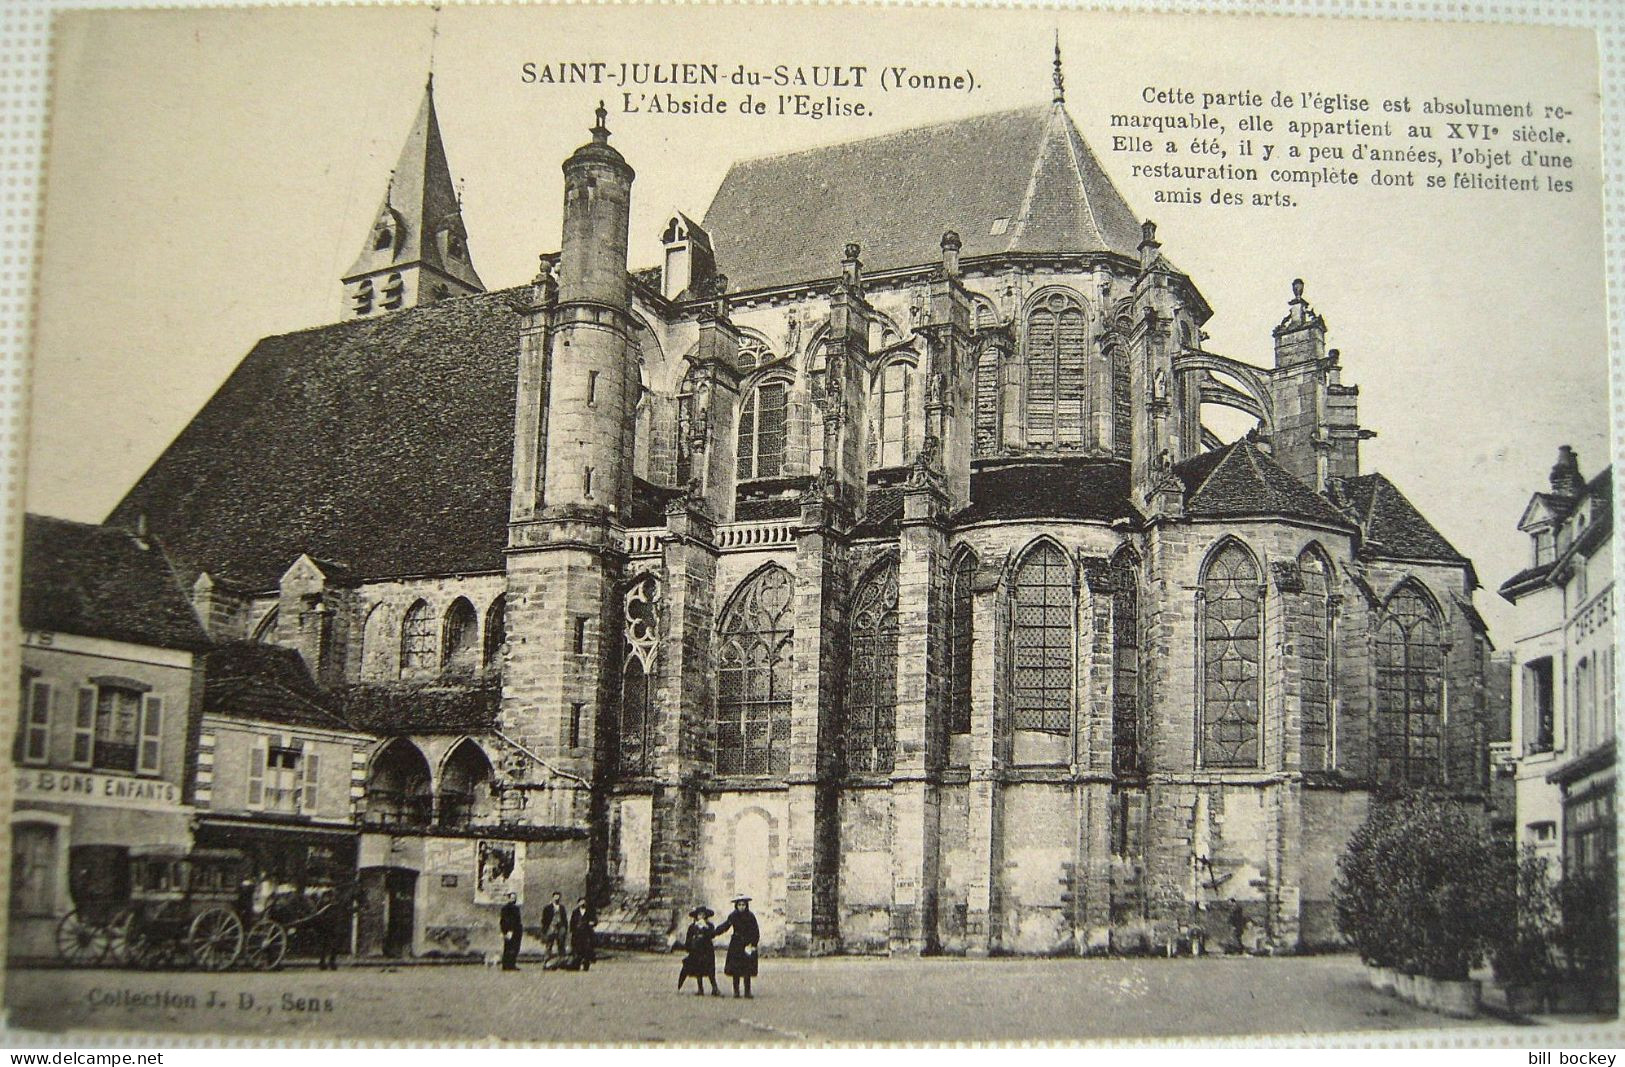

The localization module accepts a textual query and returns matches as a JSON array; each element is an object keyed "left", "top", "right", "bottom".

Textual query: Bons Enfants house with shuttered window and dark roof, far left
[{"left": 7, "top": 515, "right": 206, "bottom": 958}]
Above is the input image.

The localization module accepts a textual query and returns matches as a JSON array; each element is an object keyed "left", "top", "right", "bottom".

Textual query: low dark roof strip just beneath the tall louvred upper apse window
[{"left": 954, "top": 460, "right": 1139, "bottom": 525}]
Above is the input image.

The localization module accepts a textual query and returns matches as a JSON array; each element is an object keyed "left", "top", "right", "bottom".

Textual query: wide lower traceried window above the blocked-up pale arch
[{"left": 717, "top": 565, "right": 795, "bottom": 775}]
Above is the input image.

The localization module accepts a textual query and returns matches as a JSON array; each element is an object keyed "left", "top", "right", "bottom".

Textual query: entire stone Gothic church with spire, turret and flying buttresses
[{"left": 112, "top": 57, "right": 1490, "bottom": 955}]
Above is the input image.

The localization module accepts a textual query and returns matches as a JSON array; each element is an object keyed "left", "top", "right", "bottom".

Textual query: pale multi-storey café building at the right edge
[{"left": 1500, "top": 445, "right": 1615, "bottom": 875}]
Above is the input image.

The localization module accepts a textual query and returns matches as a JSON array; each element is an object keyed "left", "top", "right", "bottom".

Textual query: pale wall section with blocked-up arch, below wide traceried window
[{"left": 696, "top": 788, "right": 790, "bottom": 950}]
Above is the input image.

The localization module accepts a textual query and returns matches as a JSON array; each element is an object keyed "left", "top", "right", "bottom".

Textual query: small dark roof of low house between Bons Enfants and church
[{"left": 203, "top": 641, "right": 348, "bottom": 729}]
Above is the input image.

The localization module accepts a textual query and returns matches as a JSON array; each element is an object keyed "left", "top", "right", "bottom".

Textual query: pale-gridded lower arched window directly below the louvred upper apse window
[{"left": 1011, "top": 541, "right": 1076, "bottom": 734}]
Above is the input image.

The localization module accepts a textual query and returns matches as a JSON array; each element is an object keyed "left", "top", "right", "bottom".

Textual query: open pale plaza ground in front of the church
[{"left": 5, "top": 955, "right": 1617, "bottom": 1048}]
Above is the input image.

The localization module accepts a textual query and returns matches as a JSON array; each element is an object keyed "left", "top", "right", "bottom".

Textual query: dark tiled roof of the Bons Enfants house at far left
[{"left": 21, "top": 515, "right": 208, "bottom": 651}]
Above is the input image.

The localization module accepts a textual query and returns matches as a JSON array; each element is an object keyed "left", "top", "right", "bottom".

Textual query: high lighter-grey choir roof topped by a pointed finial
[{"left": 704, "top": 106, "right": 1141, "bottom": 291}]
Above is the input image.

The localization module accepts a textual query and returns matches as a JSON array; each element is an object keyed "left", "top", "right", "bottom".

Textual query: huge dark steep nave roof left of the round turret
[{"left": 111, "top": 287, "right": 527, "bottom": 590}]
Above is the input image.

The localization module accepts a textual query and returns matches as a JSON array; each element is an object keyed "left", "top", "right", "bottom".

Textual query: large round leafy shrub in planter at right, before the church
[{"left": 1333, "top": 793, "right": 1516, "bottom": 981}]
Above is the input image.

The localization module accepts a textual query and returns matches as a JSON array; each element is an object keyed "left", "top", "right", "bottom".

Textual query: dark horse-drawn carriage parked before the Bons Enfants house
[{"left": 57, "top": 846, "right": 348, "bottom": 971}]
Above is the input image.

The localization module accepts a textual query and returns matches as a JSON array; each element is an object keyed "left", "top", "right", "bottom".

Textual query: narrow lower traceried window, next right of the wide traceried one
[{"left": 845, "top": 560, "right": 897, "bottom": 775}]
